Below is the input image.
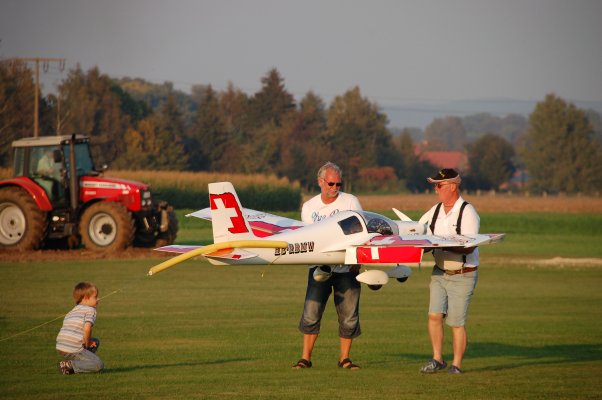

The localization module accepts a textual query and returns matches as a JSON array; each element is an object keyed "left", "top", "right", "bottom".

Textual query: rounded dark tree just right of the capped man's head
[{"left": 468, "top": 133, "right": 516, "bottom": 190}]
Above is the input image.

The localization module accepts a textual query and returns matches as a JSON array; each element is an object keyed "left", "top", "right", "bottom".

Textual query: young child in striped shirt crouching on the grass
[{"left": 56, "top": 282, "right": 104, "bottom": 375}]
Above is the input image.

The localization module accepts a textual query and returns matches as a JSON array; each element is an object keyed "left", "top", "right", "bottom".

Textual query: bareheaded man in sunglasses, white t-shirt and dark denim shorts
[{"left": 293, "top": 162, "right": 362, "bottom": 369}]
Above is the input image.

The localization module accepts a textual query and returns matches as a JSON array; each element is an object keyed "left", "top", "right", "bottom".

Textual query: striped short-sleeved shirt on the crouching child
[{"left": 56, "top": 304, "right": 96, "bottom": 353}]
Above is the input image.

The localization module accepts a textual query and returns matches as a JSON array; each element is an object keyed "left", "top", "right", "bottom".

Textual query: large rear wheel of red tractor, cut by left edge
[{"left": 0, "top": 187, "right": 48, "bottom": 250}]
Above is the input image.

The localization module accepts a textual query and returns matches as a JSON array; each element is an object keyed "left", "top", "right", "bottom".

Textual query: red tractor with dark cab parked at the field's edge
[{"left": 0, "top": 135, "right": 178, "bottom": 251}]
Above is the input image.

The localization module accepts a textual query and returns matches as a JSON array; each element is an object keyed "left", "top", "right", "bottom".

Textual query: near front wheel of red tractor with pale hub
[{"left": 79, "top": 201, "right": 134, "bottom": 251}]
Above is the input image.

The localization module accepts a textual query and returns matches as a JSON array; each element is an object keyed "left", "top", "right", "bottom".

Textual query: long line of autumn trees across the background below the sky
[{"left": 0, "top": 62, "right": 602, "bottom": 193}]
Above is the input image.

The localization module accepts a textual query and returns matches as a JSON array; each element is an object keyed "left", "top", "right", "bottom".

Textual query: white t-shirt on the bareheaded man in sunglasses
[{"left": 301, "top": 192, "right": 362, "bottom": 273}]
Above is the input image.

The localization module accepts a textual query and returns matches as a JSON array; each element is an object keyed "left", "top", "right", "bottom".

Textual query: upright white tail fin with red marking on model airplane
[{"left": 209, "top": 182, "right": 257, "bottom": 243}]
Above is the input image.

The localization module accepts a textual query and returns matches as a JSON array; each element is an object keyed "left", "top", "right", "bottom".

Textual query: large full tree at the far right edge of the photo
[{"left": 522, "top": 94, "right": 602, "bottom": 192}]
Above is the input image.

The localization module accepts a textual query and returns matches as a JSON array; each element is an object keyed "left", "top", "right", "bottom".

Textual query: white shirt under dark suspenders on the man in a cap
[{"left": 419, "top": 196, "right": 480, "bottom": 270}]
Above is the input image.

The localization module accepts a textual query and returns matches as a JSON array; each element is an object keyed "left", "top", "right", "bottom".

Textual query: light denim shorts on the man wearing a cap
[{"left": 429, "top": 267, "right": 479, "bottom": 327}]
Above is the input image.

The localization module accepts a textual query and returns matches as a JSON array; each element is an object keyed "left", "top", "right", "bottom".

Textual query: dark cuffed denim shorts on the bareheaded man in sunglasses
[{"left": 299, "top": 268, "right": 361, "bottom": 338}]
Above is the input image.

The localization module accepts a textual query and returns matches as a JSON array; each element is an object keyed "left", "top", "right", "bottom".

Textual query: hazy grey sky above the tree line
[{"left": 0, "top": 0, "right": 602, "bottom": 126}]
